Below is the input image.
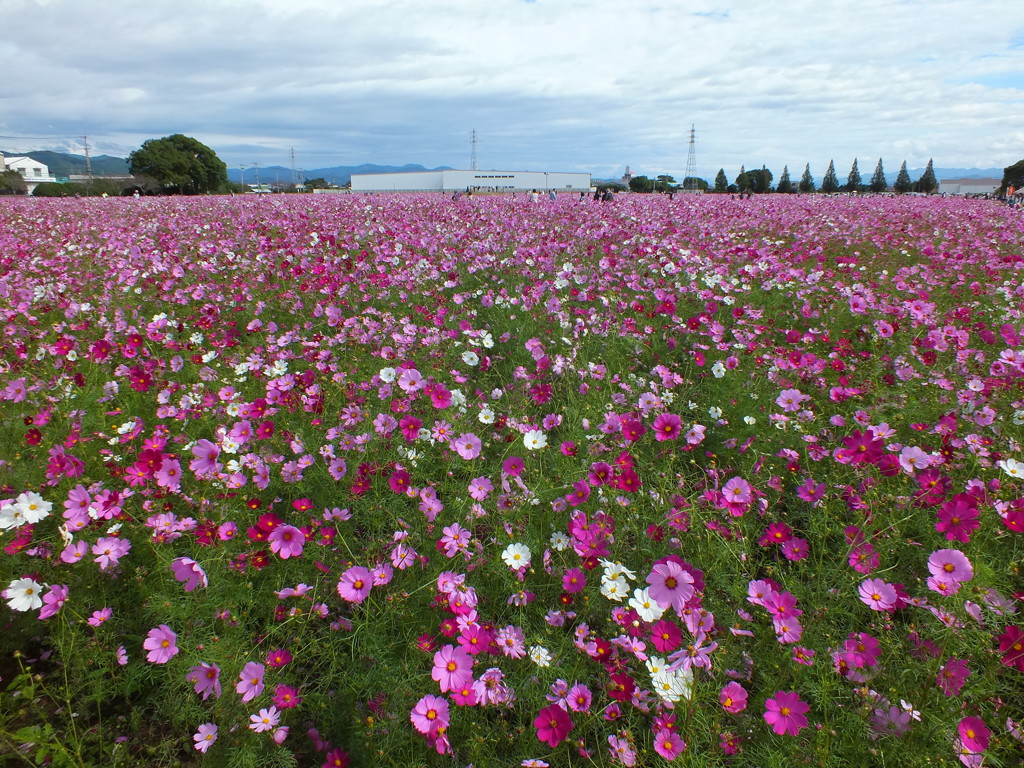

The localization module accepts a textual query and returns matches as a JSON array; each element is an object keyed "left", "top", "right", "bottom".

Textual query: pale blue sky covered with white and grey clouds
[{"left": 0, "top": 0, "right": 1024, "bottom": 180}]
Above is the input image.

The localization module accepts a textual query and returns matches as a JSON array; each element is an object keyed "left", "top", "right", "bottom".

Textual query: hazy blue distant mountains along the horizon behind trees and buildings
[{"left": 0, "top": 151, "right": 1002, "bottom": 186}]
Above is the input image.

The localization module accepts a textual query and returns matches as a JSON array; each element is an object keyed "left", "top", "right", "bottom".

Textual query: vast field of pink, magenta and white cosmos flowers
[{"left": 0, "top": 195, "right": 1024, "bottom": 767}]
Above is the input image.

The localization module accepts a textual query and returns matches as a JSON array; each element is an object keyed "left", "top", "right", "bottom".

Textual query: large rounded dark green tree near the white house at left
[{"left": 128, "top": 133, "right": 227, "bottom": 195}]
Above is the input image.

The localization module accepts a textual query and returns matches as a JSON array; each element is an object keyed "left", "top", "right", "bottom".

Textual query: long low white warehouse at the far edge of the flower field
[{"left": 352, "top": 170, "right": 590, "bottom": 193}]
